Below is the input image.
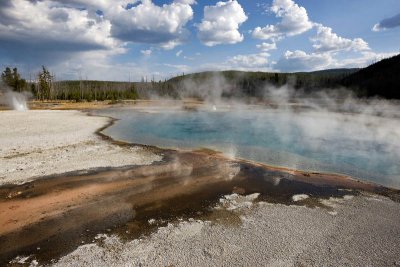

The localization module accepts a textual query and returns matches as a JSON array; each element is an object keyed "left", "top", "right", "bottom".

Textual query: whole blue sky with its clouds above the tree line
[{"left": 0, "top": 0, "right": 400, "bottom": 81}]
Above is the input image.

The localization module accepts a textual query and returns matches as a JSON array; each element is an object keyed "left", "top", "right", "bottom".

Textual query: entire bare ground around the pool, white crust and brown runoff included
[{"left": 0, "top": 106, "right": 400, "bottom": 266}]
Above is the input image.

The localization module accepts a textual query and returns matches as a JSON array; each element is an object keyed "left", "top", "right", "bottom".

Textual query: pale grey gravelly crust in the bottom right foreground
[{"left": 51, "top": 196, "right": 400, "bottom": 266}]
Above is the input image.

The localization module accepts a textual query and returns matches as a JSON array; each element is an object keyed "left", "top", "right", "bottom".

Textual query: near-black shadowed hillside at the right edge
[{"left": 341, "top": 54, "right": 400, "bottom": 99}]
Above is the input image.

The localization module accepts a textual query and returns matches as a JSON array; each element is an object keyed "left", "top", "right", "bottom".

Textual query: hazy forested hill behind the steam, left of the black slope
[{"left": 167, "top": 69, "right": 359, "bottom": 97}]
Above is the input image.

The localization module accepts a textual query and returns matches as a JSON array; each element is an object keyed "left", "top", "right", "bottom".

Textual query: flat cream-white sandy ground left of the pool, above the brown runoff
[{"left": 0, "top": 110, "right": 160, "bottom": 185}]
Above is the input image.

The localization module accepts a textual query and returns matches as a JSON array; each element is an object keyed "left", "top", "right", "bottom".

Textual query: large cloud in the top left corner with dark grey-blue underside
[{"left": 0, "top": 0, "right": 120, "bottom": 62}]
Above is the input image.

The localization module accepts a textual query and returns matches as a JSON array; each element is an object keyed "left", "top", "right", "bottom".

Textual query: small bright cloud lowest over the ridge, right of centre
[{"left": 275, "top": 50, "right": 334, "bottom": 72}]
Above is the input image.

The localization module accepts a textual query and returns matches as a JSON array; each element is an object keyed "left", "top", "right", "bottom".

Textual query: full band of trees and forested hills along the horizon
[{"left": 1, "top": 55, "right": 400, "bottom": 101}]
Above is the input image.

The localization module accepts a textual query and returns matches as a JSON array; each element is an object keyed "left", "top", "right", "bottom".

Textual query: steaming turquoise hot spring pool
[{"left": 96, "top": 108, "right": 400, "bottom": 188}]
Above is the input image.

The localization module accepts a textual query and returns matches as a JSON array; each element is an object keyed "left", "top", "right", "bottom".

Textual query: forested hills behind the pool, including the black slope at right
[{"left": 168, "top": 55, "right": 400, "bottom": 99}]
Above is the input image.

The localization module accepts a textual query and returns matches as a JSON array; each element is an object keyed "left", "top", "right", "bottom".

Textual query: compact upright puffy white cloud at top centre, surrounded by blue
[{"left": 197, "top": 0, "right": 247, "bottom": 46}]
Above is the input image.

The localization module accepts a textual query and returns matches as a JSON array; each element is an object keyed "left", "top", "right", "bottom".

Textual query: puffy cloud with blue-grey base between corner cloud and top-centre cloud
[{"left": 109, "top": 0, "right": 194, "bottom": 49}]
